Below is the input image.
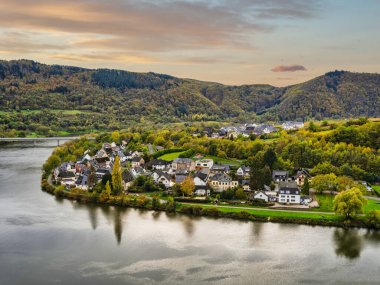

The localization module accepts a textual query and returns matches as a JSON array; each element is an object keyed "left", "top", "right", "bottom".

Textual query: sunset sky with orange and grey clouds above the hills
[{"left": 0, "top": 0, "right": 380, "bottom": 86}]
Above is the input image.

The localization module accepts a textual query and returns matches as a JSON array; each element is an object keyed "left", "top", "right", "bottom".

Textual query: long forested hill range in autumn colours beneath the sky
[{"left": 0, "top": 60, "right": 380, "bottom": 134}]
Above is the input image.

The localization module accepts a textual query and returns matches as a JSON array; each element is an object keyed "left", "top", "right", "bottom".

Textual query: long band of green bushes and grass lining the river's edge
[{"left": 41, "top": 178, "right": 380, "bottom": 229}]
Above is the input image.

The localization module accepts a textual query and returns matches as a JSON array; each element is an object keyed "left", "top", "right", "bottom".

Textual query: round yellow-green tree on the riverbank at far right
[{"left": 334, "top": 187, "right": 367, "bottom": 219}]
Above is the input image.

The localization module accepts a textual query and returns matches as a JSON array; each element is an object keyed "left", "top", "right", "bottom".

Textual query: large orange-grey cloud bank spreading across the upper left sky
[{"left": 0, "top": 0, "right": 317, "bottom": 52}]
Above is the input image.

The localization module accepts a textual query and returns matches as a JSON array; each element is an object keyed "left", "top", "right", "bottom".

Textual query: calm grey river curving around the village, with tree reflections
[{"left": 0, "top": 143, "right": 380, "bottom": 285}]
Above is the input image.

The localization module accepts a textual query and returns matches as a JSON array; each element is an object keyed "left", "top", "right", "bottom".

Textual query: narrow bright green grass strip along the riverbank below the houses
[{"left": 182, "top": 204, "right": 340, "bottom": 220}]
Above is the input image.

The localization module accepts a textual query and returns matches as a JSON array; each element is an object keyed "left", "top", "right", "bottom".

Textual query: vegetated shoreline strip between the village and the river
[{"left": 41, "top": 177, "right": 380, "bottom": 230}]
